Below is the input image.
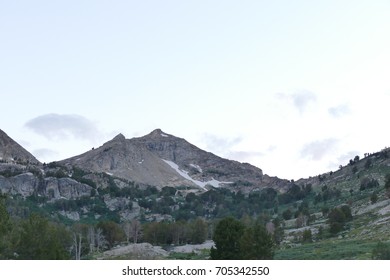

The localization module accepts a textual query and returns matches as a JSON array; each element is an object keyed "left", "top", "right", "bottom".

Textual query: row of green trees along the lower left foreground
[{"left": 0, "top": 196, "right": 209, "bottom": 260}]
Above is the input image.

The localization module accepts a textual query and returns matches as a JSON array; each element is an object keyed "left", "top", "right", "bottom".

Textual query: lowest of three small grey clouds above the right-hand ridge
[{"left": 301, "top": 138, "right": 340, "bottom": 161}]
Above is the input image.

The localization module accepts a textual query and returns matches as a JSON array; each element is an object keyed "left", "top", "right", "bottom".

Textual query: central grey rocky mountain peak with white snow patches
[{"left": 59, "top": 129, "right": 288, "bottom": 190}]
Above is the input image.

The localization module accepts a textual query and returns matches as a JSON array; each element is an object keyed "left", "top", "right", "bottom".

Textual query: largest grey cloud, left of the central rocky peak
[{"left": 25, "top": 114, "right": 102, "bottom": 143}]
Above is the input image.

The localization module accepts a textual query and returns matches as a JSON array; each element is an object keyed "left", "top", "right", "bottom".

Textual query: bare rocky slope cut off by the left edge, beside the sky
[{"left": 0, "top": 129, "right": 40, "bottom": 164}]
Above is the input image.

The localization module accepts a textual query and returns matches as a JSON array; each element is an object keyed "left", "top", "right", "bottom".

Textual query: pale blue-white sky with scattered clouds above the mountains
[{"left": 0, "top": 0, "right": 390, "bottom": 179}]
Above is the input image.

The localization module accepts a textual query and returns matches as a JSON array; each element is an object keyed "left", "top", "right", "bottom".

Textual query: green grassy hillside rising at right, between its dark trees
[{"left": 275, "top": 153, "right": 390, "bottom": 260}]
